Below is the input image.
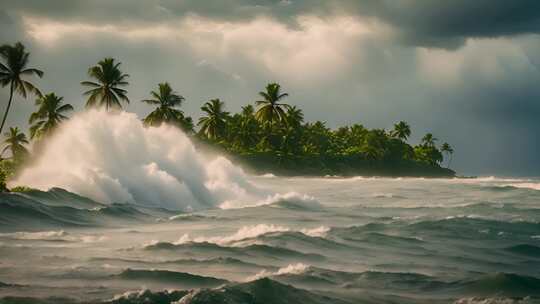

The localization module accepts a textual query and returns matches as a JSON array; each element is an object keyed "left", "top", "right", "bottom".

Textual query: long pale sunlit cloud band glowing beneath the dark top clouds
[{"left": 23, "top": 16, "right": 388, "bottom": 81}]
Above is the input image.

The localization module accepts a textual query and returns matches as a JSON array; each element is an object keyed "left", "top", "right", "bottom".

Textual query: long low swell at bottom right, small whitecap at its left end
[{"left": 243, "top": 263, "right": 540, "bottom": 297}]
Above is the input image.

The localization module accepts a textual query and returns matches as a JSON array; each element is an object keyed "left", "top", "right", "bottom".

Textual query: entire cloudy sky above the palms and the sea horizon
[{"left": 0, "top": 0, "right": 540, "bottom": 176}]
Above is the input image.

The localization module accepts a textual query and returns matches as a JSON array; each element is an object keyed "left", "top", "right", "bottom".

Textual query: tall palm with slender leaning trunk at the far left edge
[{"left": 0, "top": 42, "right": 43, "bottom": 134}]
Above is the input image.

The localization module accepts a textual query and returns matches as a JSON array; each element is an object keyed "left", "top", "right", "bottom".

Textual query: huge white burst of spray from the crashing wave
[{"left": 12, "top": 110, "right": 267, "bottom": 210}]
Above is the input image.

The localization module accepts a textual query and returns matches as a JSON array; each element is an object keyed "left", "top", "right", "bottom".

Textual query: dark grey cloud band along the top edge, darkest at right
[{"left": 0, "top": 0, "right": 540, "bottom": 49}]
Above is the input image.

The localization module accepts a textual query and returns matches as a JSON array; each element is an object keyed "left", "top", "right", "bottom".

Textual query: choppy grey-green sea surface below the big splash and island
[{"left": 0, "top": 176, "right": 540, "bottom": 304}]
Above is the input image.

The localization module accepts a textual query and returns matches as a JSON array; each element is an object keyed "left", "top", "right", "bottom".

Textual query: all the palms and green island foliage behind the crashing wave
[{"left": 0, "top": 42, "right": 455, "bottom": 191}]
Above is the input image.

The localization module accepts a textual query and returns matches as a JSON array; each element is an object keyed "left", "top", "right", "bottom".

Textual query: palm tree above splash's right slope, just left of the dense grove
[{"left": 142, "top": 82, "right": 184, "bottom": 126}]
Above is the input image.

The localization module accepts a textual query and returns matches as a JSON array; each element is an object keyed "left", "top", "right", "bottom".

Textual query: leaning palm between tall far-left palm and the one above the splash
[{"left": 28, "top": 93, "right": 73, "bottom": 139}]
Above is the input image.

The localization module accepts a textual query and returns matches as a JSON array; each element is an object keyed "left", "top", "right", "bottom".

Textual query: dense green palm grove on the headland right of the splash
[{"left": 192, "top": 83, "right": 454, "bottom": 176}]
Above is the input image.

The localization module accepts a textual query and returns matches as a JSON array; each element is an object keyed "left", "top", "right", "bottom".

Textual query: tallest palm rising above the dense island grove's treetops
[{"left": 255, "top": 83, "right": 289, "bottom": 126}]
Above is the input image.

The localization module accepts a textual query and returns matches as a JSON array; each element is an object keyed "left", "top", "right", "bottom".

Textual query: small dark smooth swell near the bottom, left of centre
[{"left": 112, "top": 268, "right": 228, "bottom": 288}]
